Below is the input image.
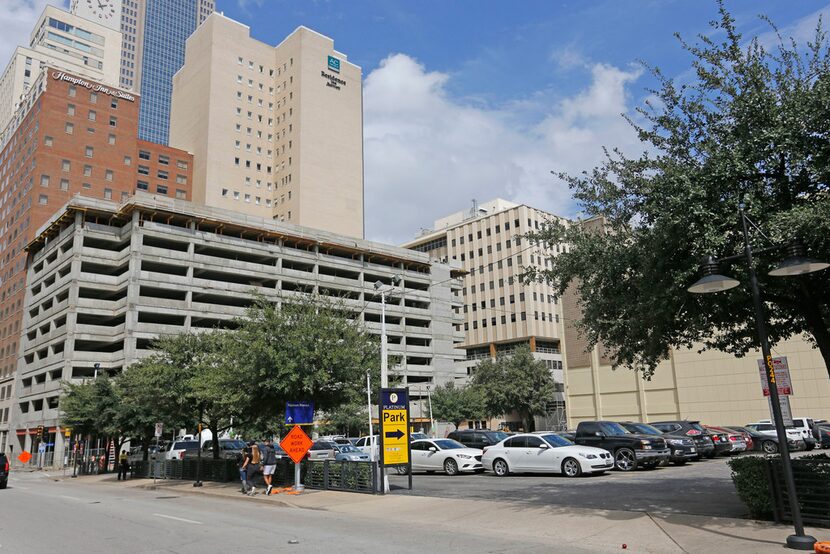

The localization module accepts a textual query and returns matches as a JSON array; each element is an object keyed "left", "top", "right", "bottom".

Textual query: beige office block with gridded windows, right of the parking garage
[{"left": 403, "top": 199, "right": 565, "bottom": 429}]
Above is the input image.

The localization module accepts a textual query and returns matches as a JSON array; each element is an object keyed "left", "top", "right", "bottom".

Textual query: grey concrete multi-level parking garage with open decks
[{"left": 14, "top": 194, "right": 460, "bottom": 463}]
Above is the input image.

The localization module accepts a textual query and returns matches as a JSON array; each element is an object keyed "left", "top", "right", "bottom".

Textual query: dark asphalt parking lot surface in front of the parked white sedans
[{"left": 389, "top": 452, "right": 747, "bottom": 518}]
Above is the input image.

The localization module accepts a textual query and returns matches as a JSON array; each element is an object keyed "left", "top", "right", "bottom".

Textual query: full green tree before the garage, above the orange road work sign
[{"left": 235, "top": 296, "right": 380, "bottom": 432}]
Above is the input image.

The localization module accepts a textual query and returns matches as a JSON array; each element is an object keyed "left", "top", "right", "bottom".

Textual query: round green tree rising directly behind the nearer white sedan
[{"left": 472, "top": 346, "right": 556, "bottom": 431}]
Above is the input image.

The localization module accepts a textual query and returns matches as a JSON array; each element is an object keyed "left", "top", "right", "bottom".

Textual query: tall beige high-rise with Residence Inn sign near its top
[{"left": 169, "top": 13, "right": 363, "bottom": 238}]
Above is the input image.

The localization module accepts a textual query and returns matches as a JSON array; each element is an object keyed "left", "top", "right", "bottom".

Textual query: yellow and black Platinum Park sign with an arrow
[{"left": 378, "top": 388, "right": 412, "bottom": 492}]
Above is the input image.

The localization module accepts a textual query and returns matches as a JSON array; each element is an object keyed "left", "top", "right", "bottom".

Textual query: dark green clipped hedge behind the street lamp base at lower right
[{"left": 729, "top": 454, "right": 830, "bottom": 526}]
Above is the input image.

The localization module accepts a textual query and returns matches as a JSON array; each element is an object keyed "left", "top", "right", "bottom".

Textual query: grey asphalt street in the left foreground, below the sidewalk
[{"left": 0, "top": 466, "right": 600, "bottom": 554}]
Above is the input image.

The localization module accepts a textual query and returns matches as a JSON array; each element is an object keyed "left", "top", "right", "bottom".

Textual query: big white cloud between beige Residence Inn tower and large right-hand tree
[{"left": 364, "top": 54, "right": 641, "bottom": 243}]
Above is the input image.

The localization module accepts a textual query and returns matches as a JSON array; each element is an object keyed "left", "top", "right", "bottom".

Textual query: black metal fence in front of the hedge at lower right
[{"left": 767, "top": 456, "right": 830, "bottom": 527}]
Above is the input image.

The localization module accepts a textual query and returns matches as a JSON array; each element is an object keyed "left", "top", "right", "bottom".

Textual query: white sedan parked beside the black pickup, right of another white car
[{"left": 481, "top": 433, "right": 614, "bottom": 477}]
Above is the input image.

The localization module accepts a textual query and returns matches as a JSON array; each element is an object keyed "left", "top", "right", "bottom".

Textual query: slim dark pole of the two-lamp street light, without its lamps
[{"left": 740, "top": 205, "right": 816, "bottom": 550}]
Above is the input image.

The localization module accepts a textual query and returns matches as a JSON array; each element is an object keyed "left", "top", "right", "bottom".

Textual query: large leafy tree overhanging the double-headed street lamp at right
[{"left": 525, "top": 4, "right": 830, "bottom": 377}]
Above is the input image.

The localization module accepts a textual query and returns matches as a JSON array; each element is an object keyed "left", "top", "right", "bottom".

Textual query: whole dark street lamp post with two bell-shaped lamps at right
[{"left": 688, "top": 204, "right": 830, "bottom": 550}]
